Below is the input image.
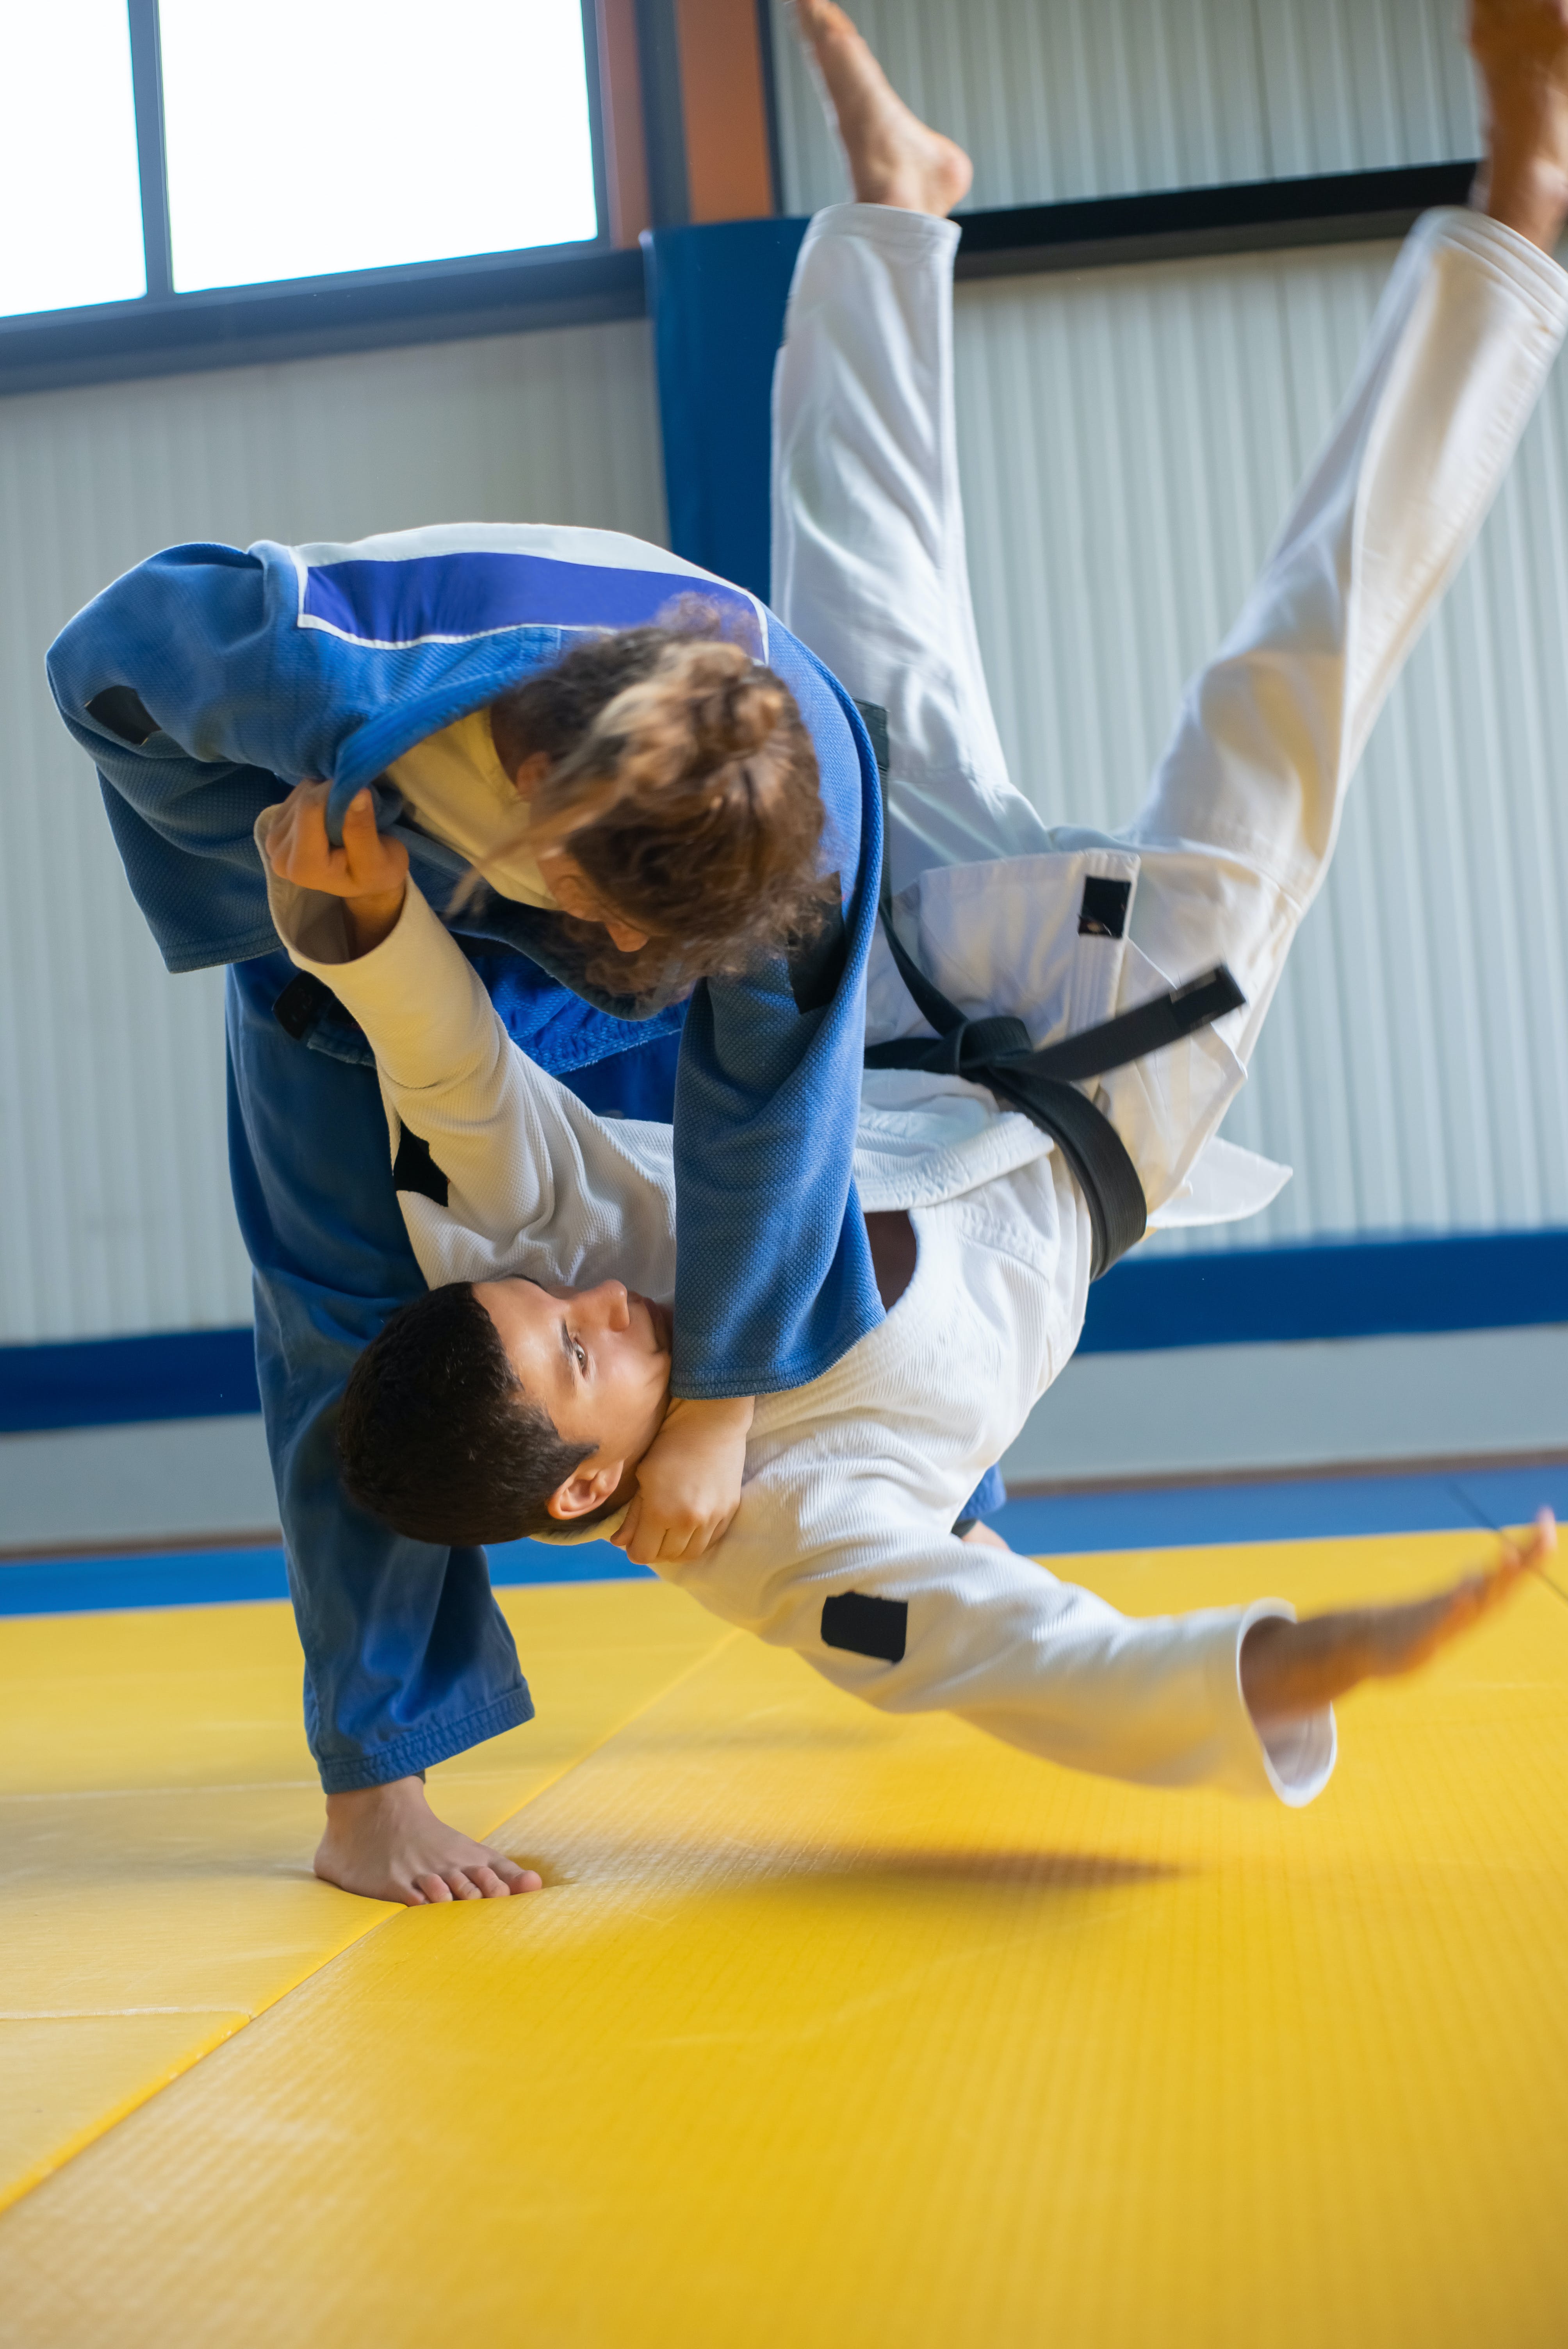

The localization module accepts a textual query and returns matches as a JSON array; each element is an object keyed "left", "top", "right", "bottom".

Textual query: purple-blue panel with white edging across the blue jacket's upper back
[{"left": 301, "top": 552, "right": 763, "bottom": 658}]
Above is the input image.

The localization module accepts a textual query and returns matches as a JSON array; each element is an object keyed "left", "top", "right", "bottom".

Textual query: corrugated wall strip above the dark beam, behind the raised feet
[{"left": 772, "top": 0, "right": 1479, "bottom": 211}]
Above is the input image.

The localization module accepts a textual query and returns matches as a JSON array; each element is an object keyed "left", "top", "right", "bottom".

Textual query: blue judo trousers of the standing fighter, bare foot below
[{"left": 228, "top": 954, "right": 1002, "bottom": 1795}]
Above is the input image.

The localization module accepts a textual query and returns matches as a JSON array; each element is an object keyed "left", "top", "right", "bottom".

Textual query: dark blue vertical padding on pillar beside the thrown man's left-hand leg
[{"left": 643, "top": 221, "right": 805, "bottom": 599}]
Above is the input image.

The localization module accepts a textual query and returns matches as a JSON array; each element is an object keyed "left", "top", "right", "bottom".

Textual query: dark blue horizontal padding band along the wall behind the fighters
[{"left": 0, "top": 1231, "right": 1568, "bottom": 1435}]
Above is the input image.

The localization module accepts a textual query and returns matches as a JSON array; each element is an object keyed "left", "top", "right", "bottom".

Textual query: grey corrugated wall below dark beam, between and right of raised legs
[{"left": 958, "top": 247, "right": 1568, "bottom": 1247}]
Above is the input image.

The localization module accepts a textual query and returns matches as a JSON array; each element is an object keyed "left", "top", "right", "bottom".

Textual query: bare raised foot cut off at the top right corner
[{"left": 1469, "top": 0, "right": 1568, "bottom": 254}]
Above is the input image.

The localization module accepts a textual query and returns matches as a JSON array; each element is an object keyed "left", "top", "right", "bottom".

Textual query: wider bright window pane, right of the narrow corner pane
[{"left": 159, "top": 0, "right": 599, "bottom": 294}]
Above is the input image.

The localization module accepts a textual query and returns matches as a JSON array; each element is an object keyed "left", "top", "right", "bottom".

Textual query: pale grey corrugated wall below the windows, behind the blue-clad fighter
[{"left": 0, "top": 324, "right": 664, "bottom": 1344}]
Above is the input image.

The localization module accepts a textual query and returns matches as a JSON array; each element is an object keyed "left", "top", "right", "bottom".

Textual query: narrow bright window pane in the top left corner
[{"left": 0, "top": 0, "right": 146, "bottom": 315}]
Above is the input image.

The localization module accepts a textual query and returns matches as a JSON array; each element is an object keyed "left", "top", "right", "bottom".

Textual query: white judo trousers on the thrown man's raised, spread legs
[{"left": 772, "top": 204, "right": 1568, "bottom": 1085}]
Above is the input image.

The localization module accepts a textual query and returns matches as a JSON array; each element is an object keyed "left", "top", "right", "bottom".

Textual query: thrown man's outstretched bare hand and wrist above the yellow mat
[{"left": 1242, "top": 1508, "right": 1556, "bottom": 1729}]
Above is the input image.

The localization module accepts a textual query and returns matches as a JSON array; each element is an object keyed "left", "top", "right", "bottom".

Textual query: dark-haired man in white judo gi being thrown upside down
[{"left": 258, "top": 7, "right": 1568, "bottom": 1900}]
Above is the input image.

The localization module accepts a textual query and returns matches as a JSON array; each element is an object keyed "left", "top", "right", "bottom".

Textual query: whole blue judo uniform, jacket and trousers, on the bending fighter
[{"left": 49, "top": 524, "right": 883, "bottom": 1792}]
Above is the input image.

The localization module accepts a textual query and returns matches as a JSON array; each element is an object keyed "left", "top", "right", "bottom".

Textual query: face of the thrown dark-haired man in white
[{"left": 474, "top": 1276, "right": 669, "bottom": 1520}]
